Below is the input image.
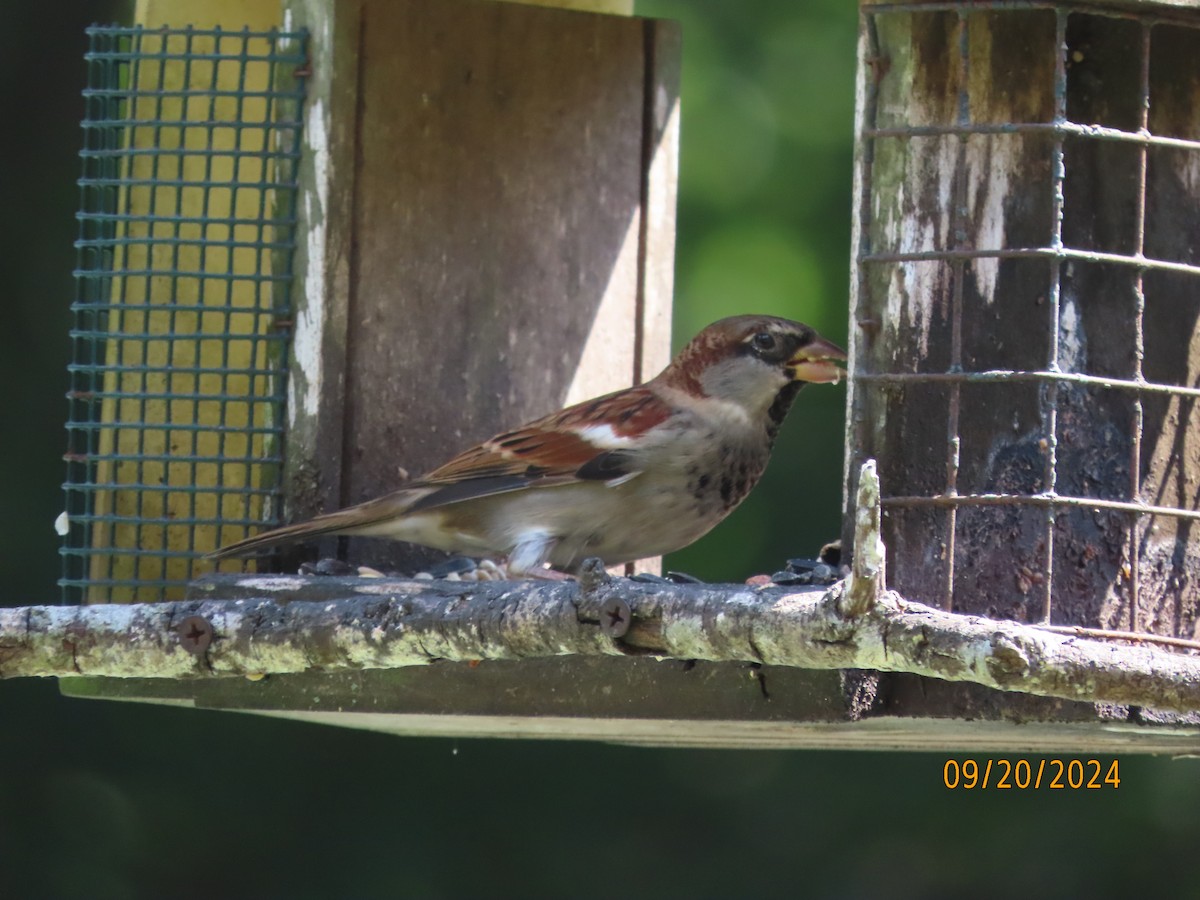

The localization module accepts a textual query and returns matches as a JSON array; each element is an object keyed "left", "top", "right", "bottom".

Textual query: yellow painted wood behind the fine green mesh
[{"left": 89, "top": 0, "right": 281, "bottom": 602}]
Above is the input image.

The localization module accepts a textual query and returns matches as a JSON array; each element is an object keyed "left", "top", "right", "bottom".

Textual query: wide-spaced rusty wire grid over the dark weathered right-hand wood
[{"left": 854, "top": 0, "right": 1200, "bottom": 631}]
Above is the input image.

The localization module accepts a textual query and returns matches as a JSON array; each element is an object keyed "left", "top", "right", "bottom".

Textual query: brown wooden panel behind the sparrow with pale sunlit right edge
[{"left": 277, "top": 0, "right": 679, "bottom": 578}]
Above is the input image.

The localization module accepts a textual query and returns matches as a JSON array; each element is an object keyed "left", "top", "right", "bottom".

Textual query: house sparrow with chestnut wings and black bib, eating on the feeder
[{"left": 211, "top": 316, "right": 846, "bottom": 575}]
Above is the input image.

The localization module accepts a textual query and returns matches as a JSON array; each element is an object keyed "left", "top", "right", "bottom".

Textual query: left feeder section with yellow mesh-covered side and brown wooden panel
[{"left": 61, "top": 0, "right": 678, "bottom": 602}]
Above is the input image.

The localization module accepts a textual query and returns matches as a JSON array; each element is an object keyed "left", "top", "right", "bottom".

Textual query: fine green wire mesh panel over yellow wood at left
[{"left": 60, "top": 26, "right": 307, "bottom": 602}]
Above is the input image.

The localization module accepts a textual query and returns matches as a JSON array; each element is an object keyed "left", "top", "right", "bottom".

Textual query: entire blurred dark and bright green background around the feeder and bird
[{"left": 0, "top": 0, "right": 1200, "bottom": 900}]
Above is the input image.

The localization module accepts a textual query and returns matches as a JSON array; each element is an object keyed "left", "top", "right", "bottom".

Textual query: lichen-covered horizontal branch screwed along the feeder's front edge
[{"left": 7, "top": 576, "right": 1200, "bottom": 712}]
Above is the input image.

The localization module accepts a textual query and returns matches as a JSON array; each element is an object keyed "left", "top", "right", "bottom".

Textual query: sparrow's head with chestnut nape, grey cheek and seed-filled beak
[{"left": 659, "top": 316, "right": 846, "bottom": 420}]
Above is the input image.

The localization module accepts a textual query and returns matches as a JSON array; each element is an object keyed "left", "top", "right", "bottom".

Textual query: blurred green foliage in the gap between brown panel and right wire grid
[{"left": 637, "top": 0, "right": 857, "bottom": 581}]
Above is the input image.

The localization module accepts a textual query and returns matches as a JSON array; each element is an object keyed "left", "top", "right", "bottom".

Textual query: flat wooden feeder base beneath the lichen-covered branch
[{"left": 59, "top": 658, "right": 1200, "bottom": 755}]
